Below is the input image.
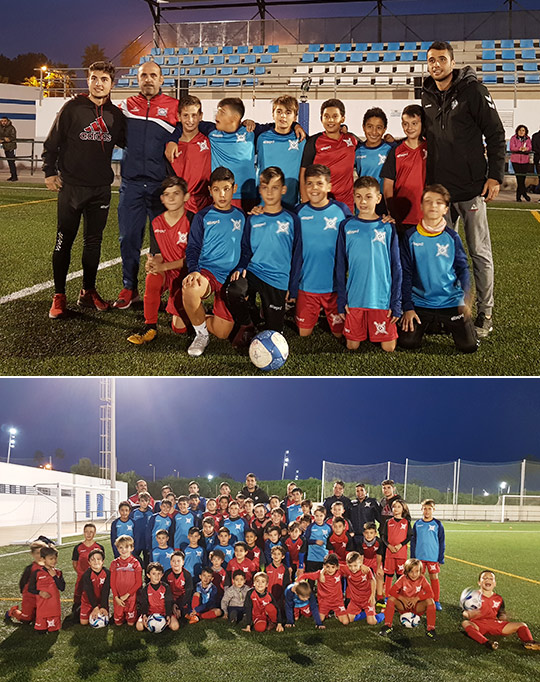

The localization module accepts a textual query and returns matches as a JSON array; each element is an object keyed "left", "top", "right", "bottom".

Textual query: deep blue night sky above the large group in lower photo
[{"left": 0, "top": 378, "right": 540, "bottom": 479}]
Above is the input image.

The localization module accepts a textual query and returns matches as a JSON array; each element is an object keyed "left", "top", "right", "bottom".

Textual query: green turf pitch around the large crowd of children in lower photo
[{"left": 0, "top": 522, "right": 540, "bottom": 682}]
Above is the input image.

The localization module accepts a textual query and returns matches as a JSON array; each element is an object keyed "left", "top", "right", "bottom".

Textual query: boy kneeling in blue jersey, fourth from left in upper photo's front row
[{"left": 292, "top": 164, "right": 352, "bottom": 338}]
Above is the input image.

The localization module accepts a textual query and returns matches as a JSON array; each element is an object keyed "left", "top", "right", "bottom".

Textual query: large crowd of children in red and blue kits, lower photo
[{"left": 6, "top": 474, "right": 540, "bottom": 650}]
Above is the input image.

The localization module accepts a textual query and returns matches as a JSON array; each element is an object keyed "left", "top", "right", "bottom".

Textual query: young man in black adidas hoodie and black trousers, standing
[{"left": 43, "top": 62, "right": 125, "bottom": 318}]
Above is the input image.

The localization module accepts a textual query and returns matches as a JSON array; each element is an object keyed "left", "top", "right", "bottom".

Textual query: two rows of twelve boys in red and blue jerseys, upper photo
[{"left": 108, "top": 85, "right": 478, "bottom": 357}]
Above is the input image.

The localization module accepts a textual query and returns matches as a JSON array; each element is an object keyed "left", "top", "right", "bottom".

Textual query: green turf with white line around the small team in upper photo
[{"left": 0, "top": 183, "right": 540, "bottom": 376}]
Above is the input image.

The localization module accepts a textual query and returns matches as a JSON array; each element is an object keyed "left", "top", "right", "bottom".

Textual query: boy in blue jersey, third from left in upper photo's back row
[{"left": 255, "top": 95, "right": 306, "bottom": 209}]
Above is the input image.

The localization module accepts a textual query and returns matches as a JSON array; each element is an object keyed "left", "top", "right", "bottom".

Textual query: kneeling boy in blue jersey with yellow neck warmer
[{"left": 399, "top": 185, "right": 478, "bottom": 353}]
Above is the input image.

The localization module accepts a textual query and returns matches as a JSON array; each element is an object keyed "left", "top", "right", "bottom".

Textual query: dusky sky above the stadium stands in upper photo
[{"left": 0, "top": 0, "right": 538, "bottom": 66}]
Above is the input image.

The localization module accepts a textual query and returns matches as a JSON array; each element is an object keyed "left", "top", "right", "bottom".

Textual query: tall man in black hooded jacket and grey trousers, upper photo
[{"left": 422, "top": 41, "right": 505, "bottom": 337}]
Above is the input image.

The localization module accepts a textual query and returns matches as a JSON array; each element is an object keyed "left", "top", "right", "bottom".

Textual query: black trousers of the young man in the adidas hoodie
[{"left": 53, "top": 184, "right": 111, "bottom": 294}]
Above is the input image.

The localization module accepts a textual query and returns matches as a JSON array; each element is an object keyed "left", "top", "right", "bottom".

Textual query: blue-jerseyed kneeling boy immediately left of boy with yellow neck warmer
[{"left": 336, "top": 176, "right": 401, "bottom": 352}]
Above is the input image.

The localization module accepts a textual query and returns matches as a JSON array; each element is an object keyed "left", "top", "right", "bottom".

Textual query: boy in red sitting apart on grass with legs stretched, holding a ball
[{"left": 461, "top": 571, "right": 540, "bottom": 651}]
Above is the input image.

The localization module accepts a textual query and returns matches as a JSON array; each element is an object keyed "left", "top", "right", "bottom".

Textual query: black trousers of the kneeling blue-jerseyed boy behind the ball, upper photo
[{"left": 225, "top": 270, "right": 287, "bottom": 332}]
